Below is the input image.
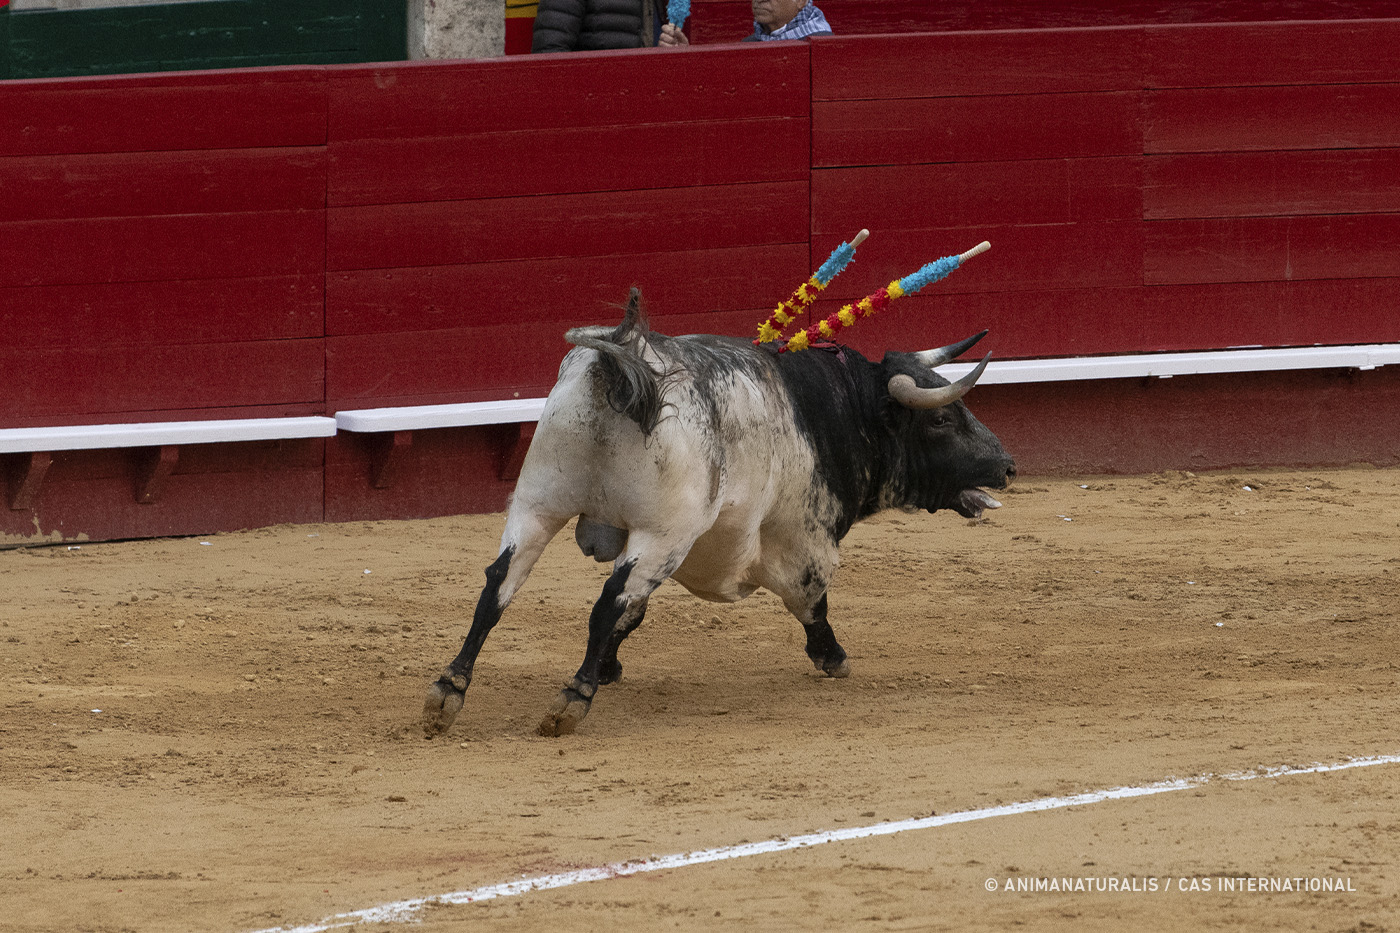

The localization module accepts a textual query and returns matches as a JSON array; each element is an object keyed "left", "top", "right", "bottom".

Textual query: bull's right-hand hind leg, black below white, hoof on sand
[{"left": 539, "top": 534, "right": 689, "bottom": 735}]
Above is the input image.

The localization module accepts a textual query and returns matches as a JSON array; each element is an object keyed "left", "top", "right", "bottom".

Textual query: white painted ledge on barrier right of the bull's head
[{"left": 938, "top": 343, "right": 1400, "bottom": 385}]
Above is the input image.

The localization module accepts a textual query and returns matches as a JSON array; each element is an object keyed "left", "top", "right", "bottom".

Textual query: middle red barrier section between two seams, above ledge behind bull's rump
[{"left": 326, "top": 45, "right": 811, "bottom": 410}]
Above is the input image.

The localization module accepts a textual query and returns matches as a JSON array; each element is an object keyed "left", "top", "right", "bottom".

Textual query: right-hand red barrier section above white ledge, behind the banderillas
[{"left": 812, "top": 21, "right": 1400, "bottom": 367}]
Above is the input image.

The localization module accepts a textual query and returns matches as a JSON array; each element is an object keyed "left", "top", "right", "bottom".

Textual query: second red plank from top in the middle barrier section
[{"left": 329, "top": 118, "right": 811, "bottom": 206}]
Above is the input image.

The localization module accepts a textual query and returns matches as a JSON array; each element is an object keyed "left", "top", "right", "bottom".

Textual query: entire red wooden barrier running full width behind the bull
[{"left": 0, "top": 19, "right": 1400, "bottom": 542}]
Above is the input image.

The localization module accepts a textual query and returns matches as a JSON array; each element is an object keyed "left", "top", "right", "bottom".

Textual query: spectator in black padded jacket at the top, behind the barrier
[{"left": 531, "top": 0, "right": 690, "bottom": 52}]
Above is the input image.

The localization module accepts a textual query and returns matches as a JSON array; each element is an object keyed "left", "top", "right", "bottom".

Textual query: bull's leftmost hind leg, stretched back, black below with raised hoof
[{"left": 423, "top": 514, "right": 567, "bottom": 738}]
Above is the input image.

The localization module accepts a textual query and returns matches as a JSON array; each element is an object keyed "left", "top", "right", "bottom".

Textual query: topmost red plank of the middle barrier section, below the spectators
[{"left": 329, "top": 42, "right": 809, "bottom": 140}]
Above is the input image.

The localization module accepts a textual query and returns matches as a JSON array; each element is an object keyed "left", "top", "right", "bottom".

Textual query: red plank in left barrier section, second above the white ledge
[{"left": 0, "top": 273, "right": 325, "bottom": 350}]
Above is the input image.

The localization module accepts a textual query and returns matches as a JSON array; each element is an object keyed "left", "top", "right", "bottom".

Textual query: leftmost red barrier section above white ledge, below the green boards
[{"left": 0, "top": 69, "right": 326, "bottom": 426}]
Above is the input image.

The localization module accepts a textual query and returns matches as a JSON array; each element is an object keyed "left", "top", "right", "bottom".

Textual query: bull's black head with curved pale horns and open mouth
[{"left": 881, "top": 331, "right": 1016, "bottom": 518}]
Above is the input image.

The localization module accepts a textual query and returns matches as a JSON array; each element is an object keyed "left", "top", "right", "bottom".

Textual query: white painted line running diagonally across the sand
[{"left": 255, "top": 755, "right": 1400, "bottom": 933}]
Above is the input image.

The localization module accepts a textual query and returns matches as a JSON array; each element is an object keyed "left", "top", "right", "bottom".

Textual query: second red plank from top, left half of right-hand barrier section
[{"left": 812, "top": 92, "right": 1142, "bottom": 167}]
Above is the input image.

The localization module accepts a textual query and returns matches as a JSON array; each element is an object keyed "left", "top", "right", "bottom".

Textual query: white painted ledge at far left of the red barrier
[{"left": 0, "top": 416, "right": 336, "bottom": 454}]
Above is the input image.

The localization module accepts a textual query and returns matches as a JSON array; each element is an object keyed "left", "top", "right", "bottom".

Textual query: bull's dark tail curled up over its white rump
[{"left": 564, "top": 287, "right": 672, "bottom": 436}]
